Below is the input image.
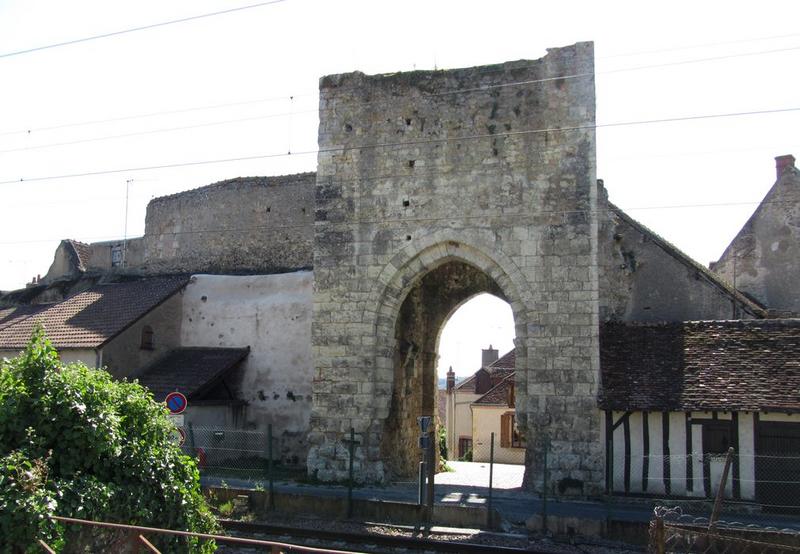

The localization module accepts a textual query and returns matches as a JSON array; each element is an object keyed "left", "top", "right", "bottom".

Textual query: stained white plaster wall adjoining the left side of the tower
[{"left": 181, "top": 271, "right": 313, "bottom": 463}]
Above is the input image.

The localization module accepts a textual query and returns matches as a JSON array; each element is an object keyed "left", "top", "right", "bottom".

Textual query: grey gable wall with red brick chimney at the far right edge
[{"left": 712, "top": 162, "right": 800, "bottom": 316}]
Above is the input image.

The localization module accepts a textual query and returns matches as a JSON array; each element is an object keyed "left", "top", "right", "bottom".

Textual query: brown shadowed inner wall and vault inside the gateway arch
[{"left": 381, "top": 260, "right": 513, "bottom": 477}]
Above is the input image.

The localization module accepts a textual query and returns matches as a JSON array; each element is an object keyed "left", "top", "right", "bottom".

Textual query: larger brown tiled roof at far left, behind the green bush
[{"left": 0, "top": 277, "right": 188, "bottom": 349}]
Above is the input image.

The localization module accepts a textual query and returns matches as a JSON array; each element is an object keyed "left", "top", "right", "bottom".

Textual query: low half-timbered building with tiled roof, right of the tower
[{"left": 598, "top": 319, "right": 800, "bottom": 507}]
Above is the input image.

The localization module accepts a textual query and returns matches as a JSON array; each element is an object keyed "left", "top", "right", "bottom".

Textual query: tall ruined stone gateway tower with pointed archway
[{"left": 308, "top": 43, "right": 604, "bottom": 493}]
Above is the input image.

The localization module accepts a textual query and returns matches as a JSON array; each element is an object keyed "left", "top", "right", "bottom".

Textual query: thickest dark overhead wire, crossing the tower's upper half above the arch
[{"left": 0, "top": 107, "right": 800, "bottom": 185}]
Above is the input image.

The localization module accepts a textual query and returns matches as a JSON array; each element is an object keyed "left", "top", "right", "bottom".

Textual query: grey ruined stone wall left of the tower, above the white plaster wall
[{"left": 140, "top": 173, "right": 314, "bottom": 273}]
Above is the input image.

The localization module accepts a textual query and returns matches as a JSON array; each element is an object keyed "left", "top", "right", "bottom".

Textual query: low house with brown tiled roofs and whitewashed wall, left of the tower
[{"left": 0, "top": 270, "right": 312, "bottom": 464}]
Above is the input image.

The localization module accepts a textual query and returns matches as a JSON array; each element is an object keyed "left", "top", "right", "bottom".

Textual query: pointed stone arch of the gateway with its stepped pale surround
[{"left": 363, "top": 233, "right": 527, "bottom": 474}]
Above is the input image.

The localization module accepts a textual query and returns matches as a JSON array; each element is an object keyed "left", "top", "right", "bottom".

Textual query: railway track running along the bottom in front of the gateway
[{"left": 220, "top": 520, "right": 549, "bottom": 554}]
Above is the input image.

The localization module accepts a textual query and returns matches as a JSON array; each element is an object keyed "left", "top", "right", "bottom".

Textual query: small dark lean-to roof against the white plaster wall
[{"left": 139, "top": 347, "right": 250, "bottom": 402}]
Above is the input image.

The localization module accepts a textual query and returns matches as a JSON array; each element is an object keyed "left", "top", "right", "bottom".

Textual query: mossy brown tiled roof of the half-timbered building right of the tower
[{"left": 598, "top": 319, "right": 800, "bottom": 413}]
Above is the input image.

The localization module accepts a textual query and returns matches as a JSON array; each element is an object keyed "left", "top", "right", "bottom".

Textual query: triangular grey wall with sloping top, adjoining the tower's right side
[{"left": 598, "top": 189, "right": 761, "bottom": 321}]
